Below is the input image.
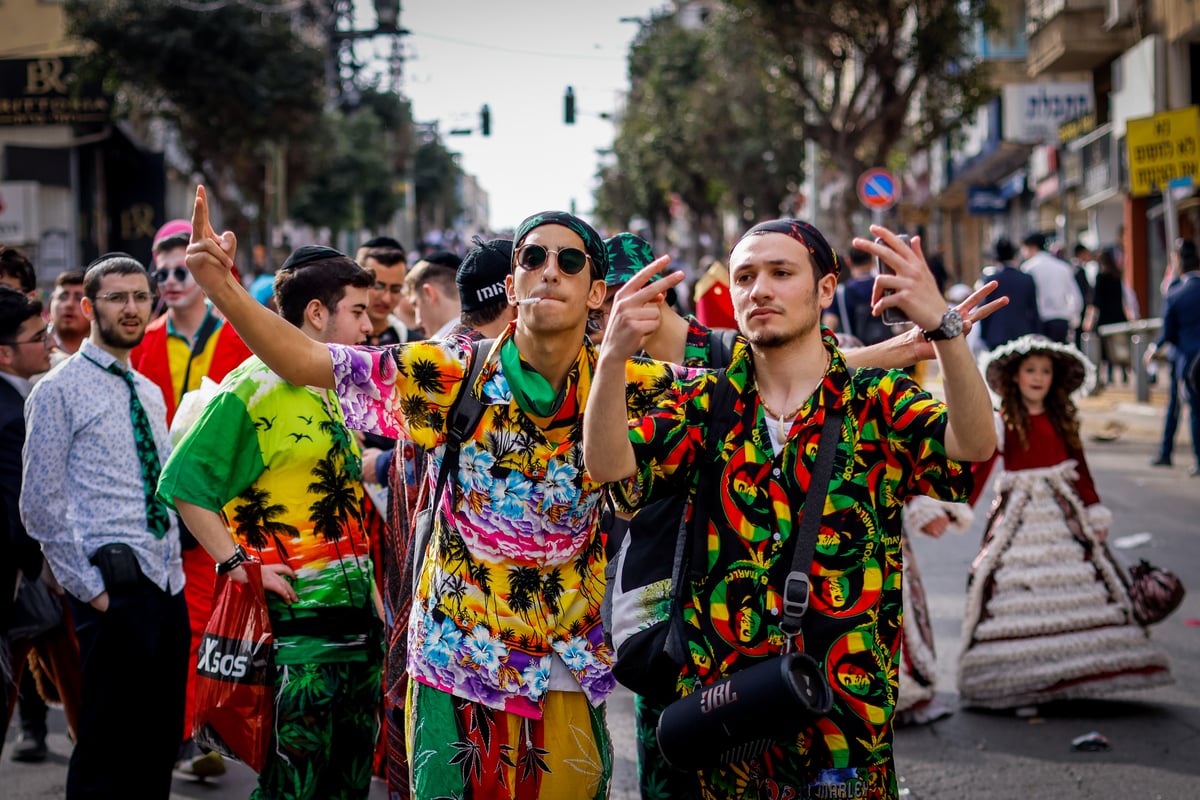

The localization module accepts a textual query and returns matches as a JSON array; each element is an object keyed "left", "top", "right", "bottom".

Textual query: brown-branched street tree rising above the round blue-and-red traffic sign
[{"left": 731, "top": 0, "right": 998, "bottom": 241}]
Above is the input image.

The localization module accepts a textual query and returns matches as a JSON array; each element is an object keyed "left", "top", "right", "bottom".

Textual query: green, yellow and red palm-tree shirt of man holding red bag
[{"left": 158, "top": 356, "right": 377, "bottom": 663}]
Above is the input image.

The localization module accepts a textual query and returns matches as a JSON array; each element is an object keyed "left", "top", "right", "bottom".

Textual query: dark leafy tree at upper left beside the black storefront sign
[{"left": 66, "top": 0, "right": 324, "bottom": 245}]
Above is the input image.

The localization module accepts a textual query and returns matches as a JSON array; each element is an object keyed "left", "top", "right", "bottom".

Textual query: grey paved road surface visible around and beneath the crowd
[{"left": 0, "top": 392, "right": 1200, "bottom": 800}]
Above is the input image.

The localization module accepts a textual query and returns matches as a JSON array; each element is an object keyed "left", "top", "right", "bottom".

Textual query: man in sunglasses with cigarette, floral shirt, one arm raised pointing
[{"left": 187, "top": 188, "right": 614, "bottom": 798}]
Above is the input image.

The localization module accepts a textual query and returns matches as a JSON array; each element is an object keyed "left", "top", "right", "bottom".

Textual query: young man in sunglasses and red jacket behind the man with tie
[{"left": 130, "top": 219, "right": 251, "bottom": 777}]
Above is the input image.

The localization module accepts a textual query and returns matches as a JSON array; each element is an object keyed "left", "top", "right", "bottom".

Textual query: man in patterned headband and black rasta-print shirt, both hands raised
[{"left": 583, "top": 219, "right": 996, "bottom": 800}]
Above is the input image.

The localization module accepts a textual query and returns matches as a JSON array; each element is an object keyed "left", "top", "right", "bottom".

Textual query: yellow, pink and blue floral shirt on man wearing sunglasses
[{"left": 329, "top": 326, "right": 614, "bottom": 718}]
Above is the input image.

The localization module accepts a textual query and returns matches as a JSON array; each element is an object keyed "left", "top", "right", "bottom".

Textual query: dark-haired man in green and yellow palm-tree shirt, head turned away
[{"left": 158, "top": 247, "right": 382, "bottom": 798}]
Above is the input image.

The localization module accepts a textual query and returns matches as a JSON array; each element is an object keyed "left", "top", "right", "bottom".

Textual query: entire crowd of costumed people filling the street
[{"left": 0, "top": 195, "right": 1180, "bottom": 799}]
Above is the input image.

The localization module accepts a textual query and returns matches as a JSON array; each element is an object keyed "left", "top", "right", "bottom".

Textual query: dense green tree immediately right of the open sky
[{"left": 598, "top": 8, "right": 803, "bottom": 256}]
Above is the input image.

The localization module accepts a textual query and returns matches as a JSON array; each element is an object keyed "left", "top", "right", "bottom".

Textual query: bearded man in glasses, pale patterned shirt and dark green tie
[{"left": 20, "top": 253, "right": 190, "bottom": 799}]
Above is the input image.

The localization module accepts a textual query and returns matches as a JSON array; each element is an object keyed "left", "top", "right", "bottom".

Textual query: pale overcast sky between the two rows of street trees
[{"left": 376, "top": 0, "right": 664, "bottom": 229}]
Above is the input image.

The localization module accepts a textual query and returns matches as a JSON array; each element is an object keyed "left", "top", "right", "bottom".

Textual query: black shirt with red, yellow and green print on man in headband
[{"left": 617, "top": 335, "right": 970, "bottom": 798}]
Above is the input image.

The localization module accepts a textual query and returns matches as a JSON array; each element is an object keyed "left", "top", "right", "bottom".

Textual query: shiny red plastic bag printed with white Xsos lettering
[{"left": 192, "top": 561, "right": 275, "bottom": 772}]
